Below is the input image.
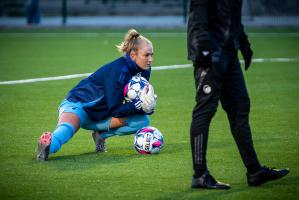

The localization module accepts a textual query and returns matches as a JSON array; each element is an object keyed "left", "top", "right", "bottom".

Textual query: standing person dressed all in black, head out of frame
[{"left": 188, "top": 0, "right": 289, "bottom": 189}]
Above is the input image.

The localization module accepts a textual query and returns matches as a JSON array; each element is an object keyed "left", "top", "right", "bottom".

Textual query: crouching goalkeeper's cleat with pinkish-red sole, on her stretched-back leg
[{"left": 36, "top": 132, "right": 52, "bottom": 161}]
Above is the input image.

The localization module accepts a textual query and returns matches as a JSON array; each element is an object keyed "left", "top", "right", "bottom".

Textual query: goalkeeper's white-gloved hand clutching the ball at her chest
[{"left": 140, "top": 85, "right": 158, "bottom": 114}]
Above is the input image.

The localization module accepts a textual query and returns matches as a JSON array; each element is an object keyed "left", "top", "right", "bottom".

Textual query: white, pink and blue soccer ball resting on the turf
[{"left": 134, "top": 126, "right": 164, "bottom": 154}]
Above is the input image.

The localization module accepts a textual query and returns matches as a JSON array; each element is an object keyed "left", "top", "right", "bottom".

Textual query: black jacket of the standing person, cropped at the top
[{"left": 187, "top": 0, "right": 250, "bottom": 61}]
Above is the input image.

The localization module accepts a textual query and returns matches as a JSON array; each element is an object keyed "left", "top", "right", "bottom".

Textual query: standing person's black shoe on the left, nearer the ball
[{"left": 191, "top": 171, "right": 230, "bottom": 190}]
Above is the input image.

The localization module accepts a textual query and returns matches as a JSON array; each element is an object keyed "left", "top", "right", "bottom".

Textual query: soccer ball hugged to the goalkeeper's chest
[{"left": 124, "top": 75, "right": 149, "bottom": 102}]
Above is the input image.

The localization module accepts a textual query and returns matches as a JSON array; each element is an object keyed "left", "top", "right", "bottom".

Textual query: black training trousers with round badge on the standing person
[{"left": 190, "top": 50, "right": 260, "bottom": 176}]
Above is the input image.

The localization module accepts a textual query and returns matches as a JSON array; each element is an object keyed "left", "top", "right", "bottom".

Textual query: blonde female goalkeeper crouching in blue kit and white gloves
[{"left": 37, "top": 29, "right": 156, "bottom": 161}]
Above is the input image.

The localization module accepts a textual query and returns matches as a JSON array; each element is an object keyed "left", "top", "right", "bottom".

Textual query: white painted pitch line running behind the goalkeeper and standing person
[{"left": 0, "top": 58, "right": 299, "bottom": 85}]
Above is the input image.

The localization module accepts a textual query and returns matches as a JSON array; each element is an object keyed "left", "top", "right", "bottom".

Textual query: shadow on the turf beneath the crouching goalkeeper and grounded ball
[{"left": 30, "top": 143, "right": 189, "bottom": 170}]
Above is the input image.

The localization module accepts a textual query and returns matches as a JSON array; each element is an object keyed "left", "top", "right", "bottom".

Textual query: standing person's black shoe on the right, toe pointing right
[{"left": 246, "top": 166, "right": 290, "bottom": 186}]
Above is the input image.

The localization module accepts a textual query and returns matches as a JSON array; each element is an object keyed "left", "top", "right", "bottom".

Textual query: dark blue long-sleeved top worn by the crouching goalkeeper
[{"left": 66, "top": 54, "right": 151, "bottom": 121}]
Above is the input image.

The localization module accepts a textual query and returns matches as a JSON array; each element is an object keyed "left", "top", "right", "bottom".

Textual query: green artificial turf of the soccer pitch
[{"left": 0, "top": 29, "right": 299, "bottom": 200}]
